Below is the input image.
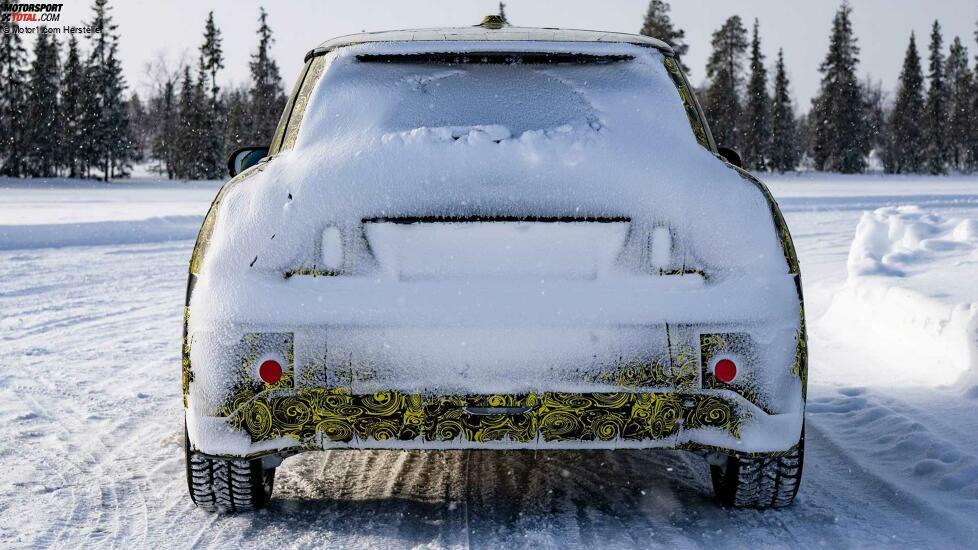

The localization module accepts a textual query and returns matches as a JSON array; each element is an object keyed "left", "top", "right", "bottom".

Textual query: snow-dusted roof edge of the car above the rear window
[{"left": 304, "top": 25, "right": 676, "bottom": 61}]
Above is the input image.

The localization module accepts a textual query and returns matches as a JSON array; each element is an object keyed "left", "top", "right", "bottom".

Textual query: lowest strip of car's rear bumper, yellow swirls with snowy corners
[{"left": 188, "top": 388, "right": 803, "bottom": 457}]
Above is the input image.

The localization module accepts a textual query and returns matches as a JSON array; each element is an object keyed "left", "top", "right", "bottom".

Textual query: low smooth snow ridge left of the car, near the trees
[{"left": 0, "top": 216, "right": 203, "bottom": 250}]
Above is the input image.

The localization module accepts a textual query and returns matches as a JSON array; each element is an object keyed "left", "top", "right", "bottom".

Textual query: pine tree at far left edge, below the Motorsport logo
[{"left": 0, "top": 23, "right": 28, "bottom": 177}]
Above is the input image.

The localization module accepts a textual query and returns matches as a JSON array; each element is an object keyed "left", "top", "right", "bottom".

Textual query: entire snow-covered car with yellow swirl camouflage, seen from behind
[{"left": 183, "top": 18, "right": 807, "bottom": 511}]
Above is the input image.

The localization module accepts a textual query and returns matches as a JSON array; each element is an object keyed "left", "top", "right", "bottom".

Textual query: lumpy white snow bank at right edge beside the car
[{"left": 820, "top": 206, "right": 978, "bottom": 385}]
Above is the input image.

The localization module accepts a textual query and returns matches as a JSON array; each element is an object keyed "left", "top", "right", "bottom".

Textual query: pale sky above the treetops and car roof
[{"left": 55, "top": 0, "right": 978, "bottom": 106}]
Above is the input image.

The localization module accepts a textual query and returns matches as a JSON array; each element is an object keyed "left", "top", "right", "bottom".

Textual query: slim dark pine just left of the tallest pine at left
[{"left": 58, "top": 34, "right": 85, "bottom": 178}]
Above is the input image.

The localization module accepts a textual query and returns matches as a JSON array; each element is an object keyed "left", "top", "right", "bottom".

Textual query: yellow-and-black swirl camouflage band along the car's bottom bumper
[{"left": 221, "top": 388, "right": 746, "bottom": 448}]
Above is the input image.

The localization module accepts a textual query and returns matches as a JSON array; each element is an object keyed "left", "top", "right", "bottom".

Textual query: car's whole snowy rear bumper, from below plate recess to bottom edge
[{"left": 184, "top": 276, "right": 805, "bottom": 457}]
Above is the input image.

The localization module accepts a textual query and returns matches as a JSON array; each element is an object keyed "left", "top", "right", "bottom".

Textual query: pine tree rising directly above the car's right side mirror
[{"left": 705, "top": 15, "right": 748, "bottom": 147}]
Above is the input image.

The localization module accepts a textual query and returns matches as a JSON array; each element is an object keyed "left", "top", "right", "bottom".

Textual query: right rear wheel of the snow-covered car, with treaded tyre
[{"left": 710, "top": 431, "right": 805, "bottom": 508}]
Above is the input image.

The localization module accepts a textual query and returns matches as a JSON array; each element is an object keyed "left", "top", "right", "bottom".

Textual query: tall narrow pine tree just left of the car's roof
[{"left": 249, "top": 8, "right": 285, "bottom": 146}]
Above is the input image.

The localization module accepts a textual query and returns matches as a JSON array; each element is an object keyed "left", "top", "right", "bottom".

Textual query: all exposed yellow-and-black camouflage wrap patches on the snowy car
[{"left": 187, "top": 56, "right": 807, "bottom": 455}]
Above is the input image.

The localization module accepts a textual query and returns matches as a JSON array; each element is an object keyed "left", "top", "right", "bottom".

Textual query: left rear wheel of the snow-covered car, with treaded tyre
[{"left": 184, "top": 434, "right": 275, "bottom": 513}]
